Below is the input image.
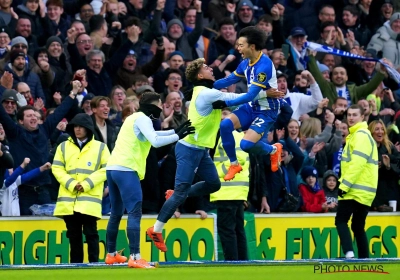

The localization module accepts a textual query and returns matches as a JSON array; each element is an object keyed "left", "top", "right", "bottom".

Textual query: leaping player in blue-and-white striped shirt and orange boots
[{"left": 213, "top": 26, "right": 285, "bottom": 181}]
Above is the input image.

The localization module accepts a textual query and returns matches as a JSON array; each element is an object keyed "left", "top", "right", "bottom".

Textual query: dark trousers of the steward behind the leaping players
[{"left": 217, "top": 200, "right": 248, "bottom": 261}]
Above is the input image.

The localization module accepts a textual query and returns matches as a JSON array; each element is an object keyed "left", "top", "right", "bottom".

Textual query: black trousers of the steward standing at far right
[{"left": 335, "top": 200, "right": 369, "bottom": 258}]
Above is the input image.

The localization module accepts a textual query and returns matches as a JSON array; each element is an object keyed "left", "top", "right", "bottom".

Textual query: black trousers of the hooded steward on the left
[{"left": 64, "top": 212, "right": 99, "bottom": 263}]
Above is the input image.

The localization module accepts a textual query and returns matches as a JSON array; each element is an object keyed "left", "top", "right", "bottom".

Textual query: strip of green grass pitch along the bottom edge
[{"left": 0, "top": 263, "right": 400, "bottom": 280}]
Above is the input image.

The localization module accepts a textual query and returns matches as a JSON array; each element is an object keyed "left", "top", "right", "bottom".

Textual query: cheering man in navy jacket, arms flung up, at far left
[{"left": 0, "top": 81, "right": 80, "bottom": 215}]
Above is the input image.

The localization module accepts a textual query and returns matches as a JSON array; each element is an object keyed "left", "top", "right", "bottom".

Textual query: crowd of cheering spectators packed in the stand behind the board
[{"left": 0, "top": 0, "right": 400, "bottom": 217}]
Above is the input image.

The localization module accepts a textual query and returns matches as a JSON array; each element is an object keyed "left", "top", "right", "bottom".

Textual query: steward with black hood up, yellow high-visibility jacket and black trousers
[{"left": 52, "top": 114, "right": 110, "bottom": 263}]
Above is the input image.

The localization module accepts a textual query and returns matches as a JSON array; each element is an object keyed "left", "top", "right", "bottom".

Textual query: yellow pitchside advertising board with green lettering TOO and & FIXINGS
[{"left": 0, "top": 213, "right": 400, "bottom": 264}]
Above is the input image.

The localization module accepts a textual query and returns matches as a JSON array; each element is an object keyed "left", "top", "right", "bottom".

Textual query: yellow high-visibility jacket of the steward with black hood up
[{"left": 52, "top": 137, "right": 110, "bottom": 219}]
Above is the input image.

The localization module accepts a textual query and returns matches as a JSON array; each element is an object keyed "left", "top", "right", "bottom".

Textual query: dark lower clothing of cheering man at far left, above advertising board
[{"left": 18, "top": 184, "right": 51, "bottom": 216}]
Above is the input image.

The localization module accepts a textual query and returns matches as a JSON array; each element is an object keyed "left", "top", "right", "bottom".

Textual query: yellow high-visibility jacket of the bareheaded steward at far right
[{"left": 339, "top": 122, "right": 379, "bottom": 206}]
